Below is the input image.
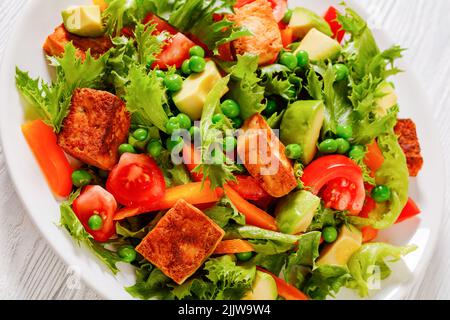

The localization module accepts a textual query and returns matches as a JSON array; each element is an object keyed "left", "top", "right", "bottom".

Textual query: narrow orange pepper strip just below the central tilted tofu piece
[{"left": 224, "top": 185, "right": 278, "bottom": 231}]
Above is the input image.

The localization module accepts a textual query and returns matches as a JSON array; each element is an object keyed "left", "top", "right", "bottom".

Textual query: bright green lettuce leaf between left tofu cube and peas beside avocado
[{"left": 125, "top": 65, "right": 169, "bottom": 132}]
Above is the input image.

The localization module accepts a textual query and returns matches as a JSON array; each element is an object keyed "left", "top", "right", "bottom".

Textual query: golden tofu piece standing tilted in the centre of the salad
[{"left": 238, "top": 114, "right": 298, "bottom": 198}]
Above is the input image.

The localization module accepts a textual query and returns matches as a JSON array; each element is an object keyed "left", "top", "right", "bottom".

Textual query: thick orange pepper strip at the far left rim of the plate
[{"left": 22, "top": 120, "right": 73, "bottom": 198}]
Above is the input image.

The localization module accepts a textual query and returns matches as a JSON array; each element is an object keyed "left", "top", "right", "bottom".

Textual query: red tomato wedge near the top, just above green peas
[{"left": 153, "top": 32, "right": 195, "bottom": 70}]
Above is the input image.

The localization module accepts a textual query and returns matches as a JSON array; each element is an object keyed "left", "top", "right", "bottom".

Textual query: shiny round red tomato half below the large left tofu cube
[{"left": 106, "top": 153, "right": 166, "bottom": 207}]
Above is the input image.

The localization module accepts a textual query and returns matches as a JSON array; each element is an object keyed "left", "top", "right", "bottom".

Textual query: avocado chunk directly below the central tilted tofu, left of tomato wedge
[{"left": 275, "top": 190, "right": 320, "bottom": 234}]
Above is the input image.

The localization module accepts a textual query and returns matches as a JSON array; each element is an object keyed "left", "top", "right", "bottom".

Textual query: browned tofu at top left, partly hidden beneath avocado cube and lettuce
[{"left": 44, "top": 24, "right": 113, "bottom": 59}]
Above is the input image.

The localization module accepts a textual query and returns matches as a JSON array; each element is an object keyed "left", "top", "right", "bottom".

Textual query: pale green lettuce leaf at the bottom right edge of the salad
[{"left": 347, "top": 243, "right": 417, "bottom": 297}]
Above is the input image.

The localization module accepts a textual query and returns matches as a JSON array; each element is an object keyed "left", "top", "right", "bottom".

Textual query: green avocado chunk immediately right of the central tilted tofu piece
[{"left": 280, "top": 100, "right": 325, "bottom": 165}]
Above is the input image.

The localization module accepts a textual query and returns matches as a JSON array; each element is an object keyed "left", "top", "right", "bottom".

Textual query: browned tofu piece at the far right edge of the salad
[{"left": 394, "top": 119, "right": 423, "bottom": 177}]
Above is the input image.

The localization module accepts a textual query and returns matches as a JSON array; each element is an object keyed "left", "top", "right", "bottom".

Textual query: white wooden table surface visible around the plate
[{"left": 0, "top": 0, "right": 450, "bottom": 299}]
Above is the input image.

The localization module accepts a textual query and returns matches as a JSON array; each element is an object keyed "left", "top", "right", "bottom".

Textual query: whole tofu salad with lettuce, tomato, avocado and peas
[{"left": 16, "top": 0, "right": 423, "bottom": 300}]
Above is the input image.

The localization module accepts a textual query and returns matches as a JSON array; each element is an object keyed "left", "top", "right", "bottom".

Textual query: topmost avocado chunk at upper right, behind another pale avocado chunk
[{"left": 289, "top": 7, "right": 333, "bottom": 39}]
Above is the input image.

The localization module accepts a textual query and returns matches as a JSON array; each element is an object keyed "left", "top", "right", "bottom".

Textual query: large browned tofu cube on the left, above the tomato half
[{"left": 58, "top": 89, "right": 130, "bottom": 170}]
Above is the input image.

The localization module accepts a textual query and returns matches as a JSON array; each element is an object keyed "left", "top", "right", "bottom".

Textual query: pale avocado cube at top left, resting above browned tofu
[{"left": 61, "top": 5, "right": 104, "bottom": 37}]
